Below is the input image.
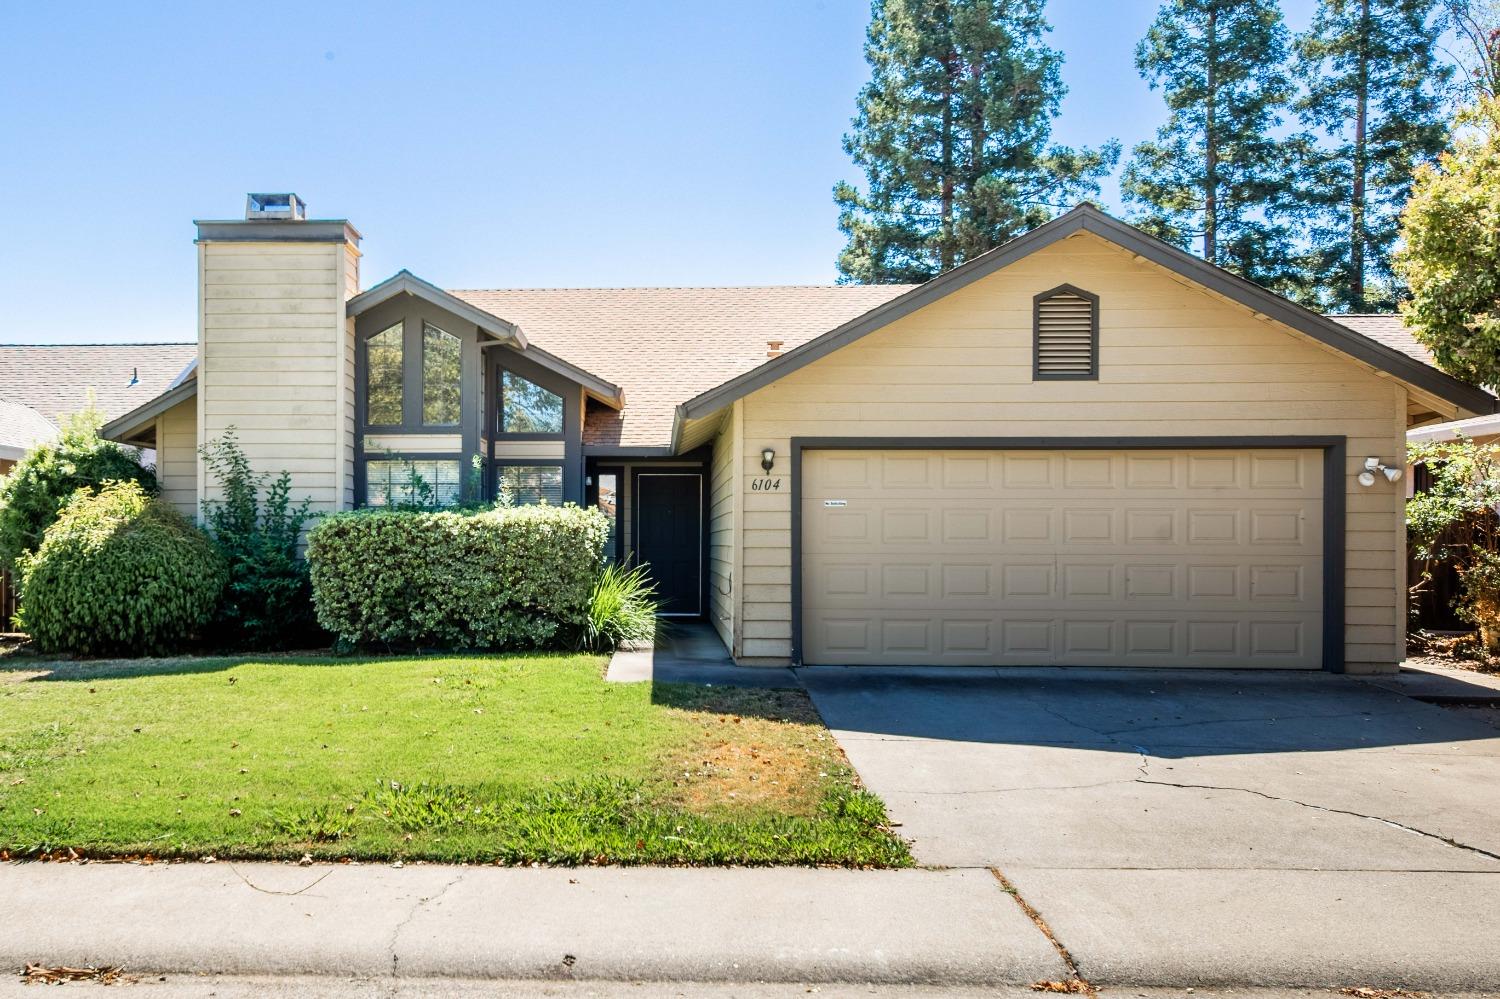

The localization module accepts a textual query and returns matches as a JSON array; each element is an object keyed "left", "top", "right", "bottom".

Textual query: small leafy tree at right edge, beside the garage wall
[{"left": 1407, "top": 437, "right": 1500, "bottom": 653}]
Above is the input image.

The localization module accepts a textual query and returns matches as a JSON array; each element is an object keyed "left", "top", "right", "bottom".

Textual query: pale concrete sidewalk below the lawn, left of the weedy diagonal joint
[{"left": 0, "top": 863, "right": 1067, "bottom": 986}]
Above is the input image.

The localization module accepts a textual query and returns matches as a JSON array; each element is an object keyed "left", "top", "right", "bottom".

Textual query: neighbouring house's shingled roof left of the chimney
[{"left": 0, "top": 344, "right": 198, "bottom": 425}]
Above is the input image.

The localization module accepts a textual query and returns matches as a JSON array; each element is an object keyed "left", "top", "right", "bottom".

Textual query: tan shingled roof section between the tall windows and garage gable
[{"left": 450, "top": 285, "right": 912, "bottom": 449}]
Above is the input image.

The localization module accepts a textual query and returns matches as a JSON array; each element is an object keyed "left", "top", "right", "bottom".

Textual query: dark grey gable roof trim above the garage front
[{"left": 674, "top": 204, "right": 1496, "bottom": 443}]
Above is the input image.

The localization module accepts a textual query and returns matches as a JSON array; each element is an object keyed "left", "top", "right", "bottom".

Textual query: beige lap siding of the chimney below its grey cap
[{"left": 197, "top": 242, "right": 357, "bottom": 512}]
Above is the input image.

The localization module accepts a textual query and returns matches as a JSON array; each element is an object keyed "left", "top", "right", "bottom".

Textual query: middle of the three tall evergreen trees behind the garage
[{"left": 1121, "top": 0, "right": 1301, "bottom": 293}]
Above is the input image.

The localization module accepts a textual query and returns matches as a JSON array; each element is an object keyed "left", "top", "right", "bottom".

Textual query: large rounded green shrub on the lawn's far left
[{"left": 18, "top": 482, "right": 225, "bottom": 656}]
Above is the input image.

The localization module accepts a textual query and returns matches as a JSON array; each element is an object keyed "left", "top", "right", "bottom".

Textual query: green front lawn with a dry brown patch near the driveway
[{"left": 0, "top": 656, "right": 911, "bottom": 866}]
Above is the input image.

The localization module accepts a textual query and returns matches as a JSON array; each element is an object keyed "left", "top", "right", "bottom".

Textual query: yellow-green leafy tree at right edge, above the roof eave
[{"left": 1395, "top": 99, "right": 1500, "bottom": 386}]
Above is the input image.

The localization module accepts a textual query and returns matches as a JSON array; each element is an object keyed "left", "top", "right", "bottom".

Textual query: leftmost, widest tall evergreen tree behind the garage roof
[{"left": 834, "top": 0, "right": 1119, "bottom": 282}]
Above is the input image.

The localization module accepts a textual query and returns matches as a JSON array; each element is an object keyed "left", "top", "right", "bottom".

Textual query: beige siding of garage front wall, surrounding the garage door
[{"left": 735, "top": 234, "right": 1407, "bottom": 671}]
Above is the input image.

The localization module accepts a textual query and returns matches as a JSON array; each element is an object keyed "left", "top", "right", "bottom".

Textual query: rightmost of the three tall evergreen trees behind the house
[{"left": 1296, "top": 0, "right": 1452, "bottom": 312}]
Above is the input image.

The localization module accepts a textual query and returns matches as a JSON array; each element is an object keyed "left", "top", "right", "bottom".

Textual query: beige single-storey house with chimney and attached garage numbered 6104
[{"left": 107, "top": 195, "right": 1496, "bottom": 671}]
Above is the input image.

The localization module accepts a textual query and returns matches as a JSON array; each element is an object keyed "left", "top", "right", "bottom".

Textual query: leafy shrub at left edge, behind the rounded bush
[{"left": 0, "top": 405, "right": 156, "bottom": 569}]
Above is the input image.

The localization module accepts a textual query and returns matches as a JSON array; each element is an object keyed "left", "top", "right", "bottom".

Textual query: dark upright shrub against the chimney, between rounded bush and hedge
[{"left": 201, "top": 428, "right": 318, "bottom": 648}]
